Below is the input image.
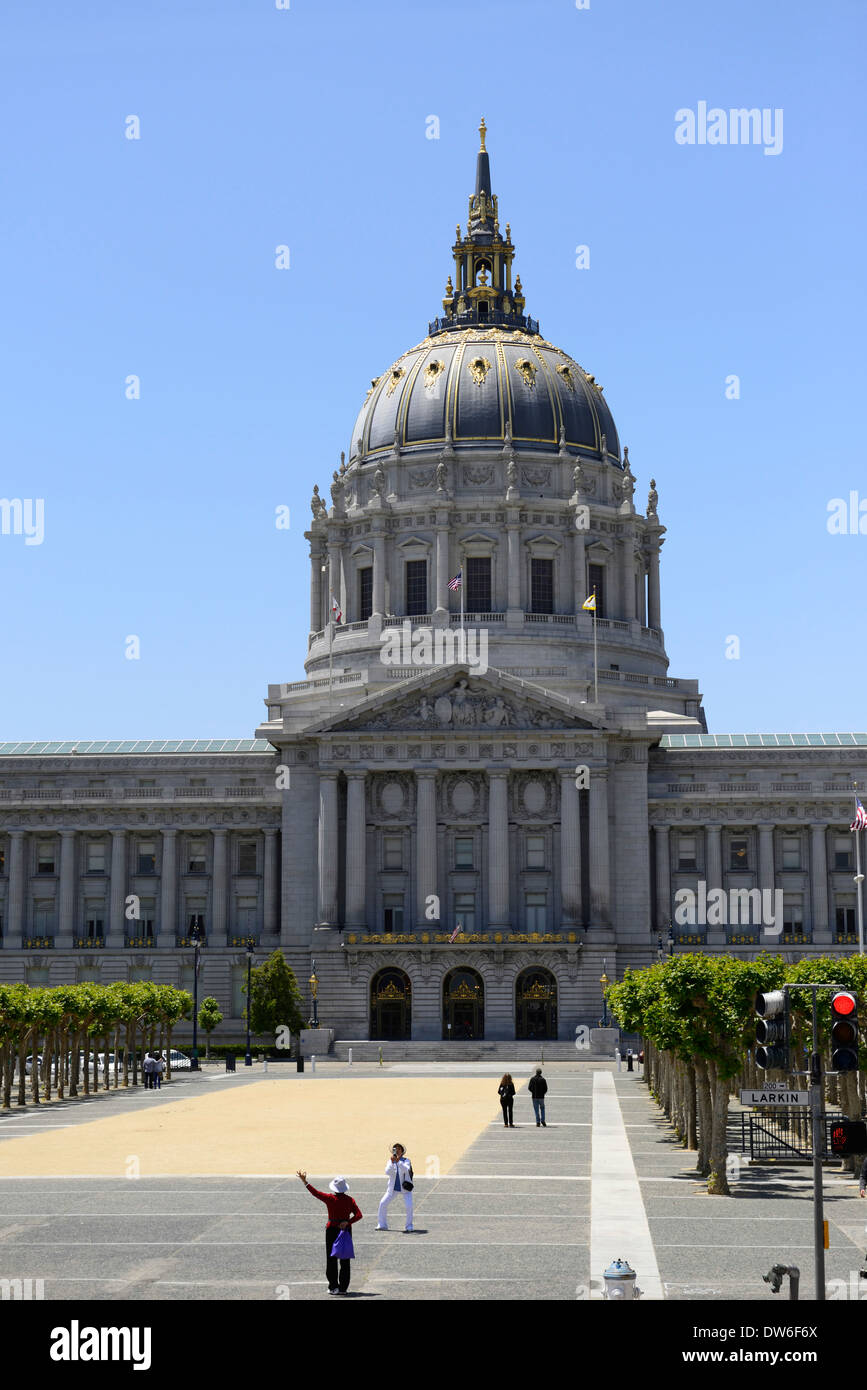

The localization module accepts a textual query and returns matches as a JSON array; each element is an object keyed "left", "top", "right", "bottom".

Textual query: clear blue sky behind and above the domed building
[{"left": 0, "top": 0, "right": 867, "bottom": 739}]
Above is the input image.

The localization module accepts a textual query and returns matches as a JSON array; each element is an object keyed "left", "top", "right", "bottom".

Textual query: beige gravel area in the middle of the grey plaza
[{"left": 0, "top": 1076, "right": 525, "bottom": 1177}]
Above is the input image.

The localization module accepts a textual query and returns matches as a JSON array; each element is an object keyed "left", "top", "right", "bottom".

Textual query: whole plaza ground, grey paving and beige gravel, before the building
[{"left": 0, "top": 1063, "right": 867, "bottom": 1304}]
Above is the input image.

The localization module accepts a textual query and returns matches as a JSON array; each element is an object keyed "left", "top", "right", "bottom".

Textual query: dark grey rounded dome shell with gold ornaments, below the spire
[{"left": 350, "top": 327, "right": 620, "bottom": 463}]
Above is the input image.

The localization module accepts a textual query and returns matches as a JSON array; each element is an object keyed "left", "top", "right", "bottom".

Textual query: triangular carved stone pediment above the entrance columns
[{"left": 307, "top": 666, "right": 609, "bottom": 737}]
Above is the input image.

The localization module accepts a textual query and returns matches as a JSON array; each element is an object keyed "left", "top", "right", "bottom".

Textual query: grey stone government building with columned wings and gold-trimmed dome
[{"left": 0, "top": 122, "right": 867, "bottom": 1055}]
